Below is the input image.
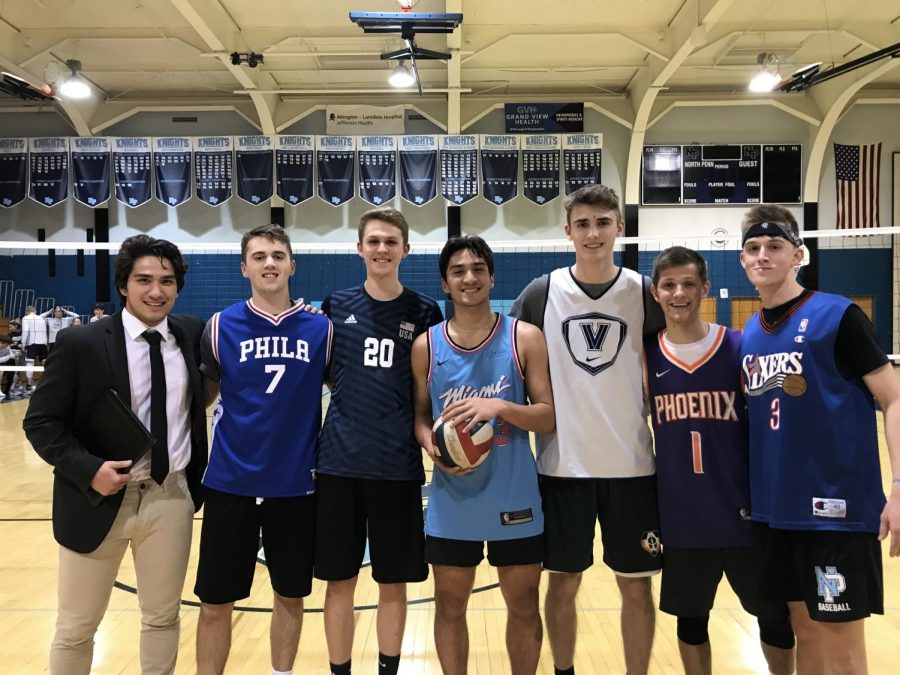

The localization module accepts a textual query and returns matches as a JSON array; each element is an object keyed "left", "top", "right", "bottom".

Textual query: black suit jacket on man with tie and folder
[{"left": 22, "top": 312, "right": 208, "bottom": 553}]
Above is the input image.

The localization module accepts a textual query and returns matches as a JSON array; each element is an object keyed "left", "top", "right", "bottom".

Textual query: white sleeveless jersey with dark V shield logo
[{"left": 537, "top": 267, "right": 656, "bottom": 478}]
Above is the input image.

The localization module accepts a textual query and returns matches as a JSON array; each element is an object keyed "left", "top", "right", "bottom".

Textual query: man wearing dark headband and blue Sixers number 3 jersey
[{"left": 741, "top": 204, "right": 900, "bottom": 675}]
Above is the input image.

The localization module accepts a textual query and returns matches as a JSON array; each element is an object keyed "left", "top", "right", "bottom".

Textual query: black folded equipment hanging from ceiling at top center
[{"left": 350, "top": 8, "right": 463, "bottom": 96}]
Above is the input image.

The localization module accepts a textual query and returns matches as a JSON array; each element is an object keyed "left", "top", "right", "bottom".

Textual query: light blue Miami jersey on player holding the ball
[{"left": 425, "top": 315, "right": 544, "bottom": 541}]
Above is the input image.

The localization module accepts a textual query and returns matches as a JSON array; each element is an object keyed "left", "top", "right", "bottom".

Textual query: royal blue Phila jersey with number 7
[{"left": 203, "top": 300, "right": 331, "bottom": 497}]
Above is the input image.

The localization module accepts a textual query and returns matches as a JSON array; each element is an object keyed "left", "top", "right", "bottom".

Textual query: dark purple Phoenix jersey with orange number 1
[{"left": 644, "top": 324, "right": 752, "bottom": 548}]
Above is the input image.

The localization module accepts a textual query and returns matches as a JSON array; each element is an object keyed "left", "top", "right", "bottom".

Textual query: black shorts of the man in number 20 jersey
[{"left": 315, "top": 473, "right": 428, "bottom": 584}]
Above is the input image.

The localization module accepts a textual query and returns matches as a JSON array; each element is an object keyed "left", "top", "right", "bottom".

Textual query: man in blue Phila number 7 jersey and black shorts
[{"left": 194, "top": 225, "right": 331, "bottom": 675}]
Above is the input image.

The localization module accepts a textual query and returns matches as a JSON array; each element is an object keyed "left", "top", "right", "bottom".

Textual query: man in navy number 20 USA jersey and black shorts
[{"left": 315, "top": 208, "right": 443, "bottom": 675}]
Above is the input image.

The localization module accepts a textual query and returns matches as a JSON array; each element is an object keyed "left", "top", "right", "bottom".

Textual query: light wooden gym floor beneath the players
[{"left": 0, "top": 394, "right": 900, "bottom": 675}]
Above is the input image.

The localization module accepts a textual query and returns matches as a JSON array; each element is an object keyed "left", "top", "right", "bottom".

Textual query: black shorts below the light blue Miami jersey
[{"left": 425, "top": 534, "right": 544, "bottom": 567}]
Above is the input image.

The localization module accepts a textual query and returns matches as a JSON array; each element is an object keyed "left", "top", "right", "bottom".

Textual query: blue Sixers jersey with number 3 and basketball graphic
[{"left": 741, "top": 292, "right": 885, "bottom": 532}]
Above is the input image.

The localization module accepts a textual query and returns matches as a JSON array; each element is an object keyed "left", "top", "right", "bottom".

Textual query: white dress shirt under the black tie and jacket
[{"left": 122, "top": 309, "right": 191, "bottom": 479}]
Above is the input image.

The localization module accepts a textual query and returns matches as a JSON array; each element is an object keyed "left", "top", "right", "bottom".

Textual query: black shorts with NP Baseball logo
[{"left": 753, "top": 522, "right": 884, "bottom": 622}]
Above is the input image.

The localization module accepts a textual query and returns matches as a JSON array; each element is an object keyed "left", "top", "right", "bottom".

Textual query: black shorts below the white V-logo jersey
[{"left": 540, "top": 475, "right": 662, "bottom": 576}]
